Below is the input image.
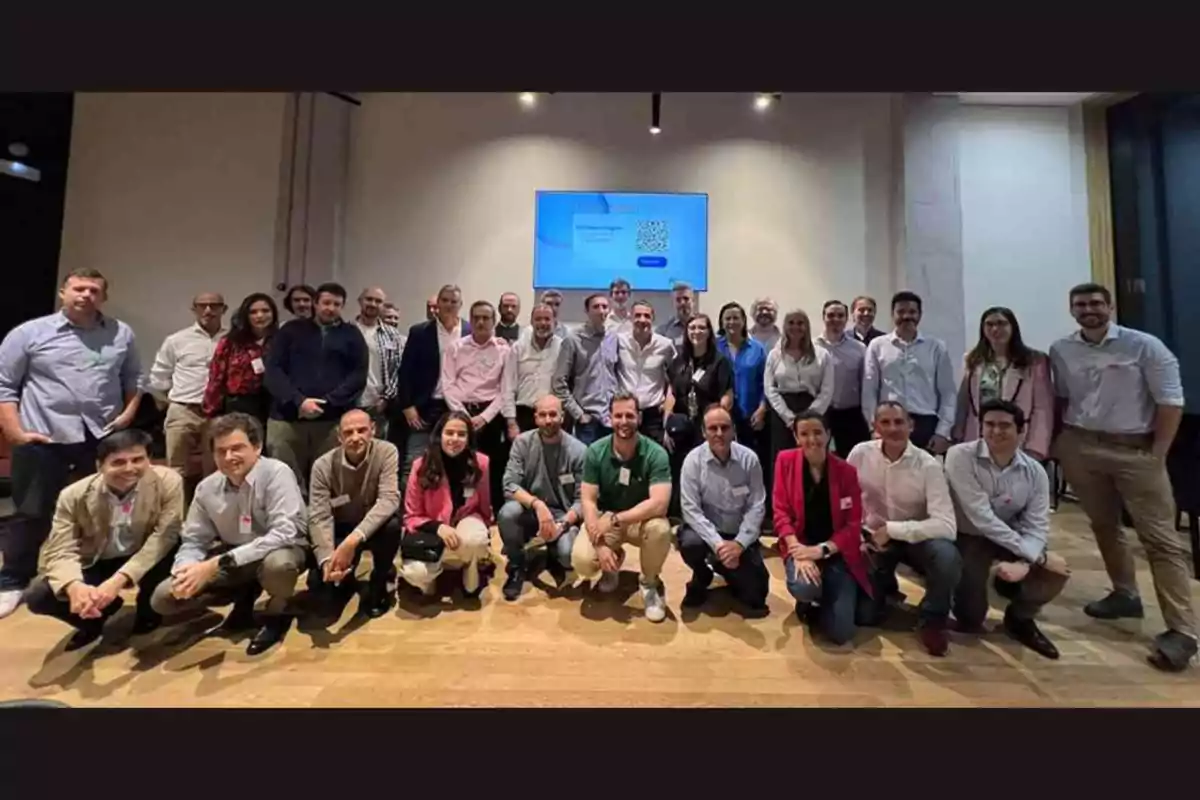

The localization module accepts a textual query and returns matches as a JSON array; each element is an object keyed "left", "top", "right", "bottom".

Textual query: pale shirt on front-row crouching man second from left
[{"left": 175, "top": 457, "right": 308, "bottom": 567}]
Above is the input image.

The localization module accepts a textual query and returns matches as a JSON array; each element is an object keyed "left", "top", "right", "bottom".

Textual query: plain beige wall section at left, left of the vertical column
[{"left": 59, "top": 92, "right": 286, "bottom": 367}]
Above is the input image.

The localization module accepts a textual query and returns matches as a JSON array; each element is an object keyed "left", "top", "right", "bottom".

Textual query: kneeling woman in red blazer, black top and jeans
[{"left": 773, "top": 410, "right": 874, "bottom": 644}]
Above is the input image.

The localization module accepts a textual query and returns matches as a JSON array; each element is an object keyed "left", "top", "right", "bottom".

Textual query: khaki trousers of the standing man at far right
[{"left": 1055, "top": 427, "right": 1196, "bottom": 637}]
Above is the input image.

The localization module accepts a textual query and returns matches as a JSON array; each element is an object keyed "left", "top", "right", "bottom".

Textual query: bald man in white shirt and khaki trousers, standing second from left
[{"left": 150, "top": 291, "right": 227, "bottom": 503}]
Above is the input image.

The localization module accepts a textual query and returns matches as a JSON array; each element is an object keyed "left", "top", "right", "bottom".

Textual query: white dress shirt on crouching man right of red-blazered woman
[{"left": 846, "top": 438, "right": 955, "bottom": 543}]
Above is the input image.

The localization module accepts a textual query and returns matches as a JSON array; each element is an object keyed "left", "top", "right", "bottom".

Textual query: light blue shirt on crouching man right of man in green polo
[{"left": 679, "top": 441, "right": 767, "bottom": 551}]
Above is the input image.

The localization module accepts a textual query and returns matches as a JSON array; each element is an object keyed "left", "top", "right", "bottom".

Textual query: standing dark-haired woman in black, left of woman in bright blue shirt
[{"left": 662, "top": 314, "right": 733, "bottom": 517}]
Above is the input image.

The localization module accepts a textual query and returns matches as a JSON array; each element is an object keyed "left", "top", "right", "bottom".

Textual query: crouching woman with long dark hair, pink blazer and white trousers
[{"left": 400, "top": 411, "right": 492, "bottom": 597}]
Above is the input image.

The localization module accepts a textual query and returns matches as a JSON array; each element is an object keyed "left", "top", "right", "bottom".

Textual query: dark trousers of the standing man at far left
[{"left": 0, "top": 429, "right": 96, "bottom": 591}]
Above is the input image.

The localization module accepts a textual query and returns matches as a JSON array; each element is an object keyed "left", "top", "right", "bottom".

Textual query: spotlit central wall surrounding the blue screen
[{"left": 340, "top": 94, "right": 893, "bottom": 324}]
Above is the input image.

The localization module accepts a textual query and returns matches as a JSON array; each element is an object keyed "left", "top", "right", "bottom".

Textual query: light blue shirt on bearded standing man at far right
[{"left": 1050, "top": 323, "right": 1183, "bottom": 434}]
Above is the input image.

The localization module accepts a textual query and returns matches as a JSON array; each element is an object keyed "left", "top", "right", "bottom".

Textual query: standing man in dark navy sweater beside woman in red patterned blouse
[{"left": 265, "top": 283, "right": 370, "bottom": 491}]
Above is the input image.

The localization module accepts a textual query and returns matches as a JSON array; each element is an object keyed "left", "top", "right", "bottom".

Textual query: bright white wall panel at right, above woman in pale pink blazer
[{"left": 952, "top": 106, "right": 1091, "bottom": 351}]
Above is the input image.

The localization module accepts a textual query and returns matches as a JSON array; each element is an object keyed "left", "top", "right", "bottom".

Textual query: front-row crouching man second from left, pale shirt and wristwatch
[{"left": 150, "top": 413, "right": 308, "bottom": 656}]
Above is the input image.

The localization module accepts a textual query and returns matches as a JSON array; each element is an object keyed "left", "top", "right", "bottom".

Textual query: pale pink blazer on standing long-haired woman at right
[{"left": 954, "top": 351, "right": 1055, "bottom": 459}]
